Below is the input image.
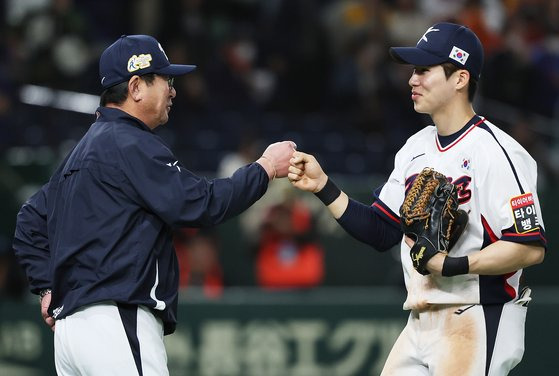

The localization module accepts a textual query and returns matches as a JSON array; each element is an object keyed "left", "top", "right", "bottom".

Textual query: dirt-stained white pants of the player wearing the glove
[{"left": 381, "top": 302, "right": 527, "bottom": 376}]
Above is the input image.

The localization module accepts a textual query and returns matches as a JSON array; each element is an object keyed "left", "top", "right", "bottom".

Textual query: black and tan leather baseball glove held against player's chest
[{"left": 400, "top": 168, "right": 468, "bottom": 275}]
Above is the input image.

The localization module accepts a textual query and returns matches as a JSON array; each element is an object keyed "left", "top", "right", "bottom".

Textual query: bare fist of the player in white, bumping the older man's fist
[{"left": 287, "top": 151, "right": 328, "bottom": 193}]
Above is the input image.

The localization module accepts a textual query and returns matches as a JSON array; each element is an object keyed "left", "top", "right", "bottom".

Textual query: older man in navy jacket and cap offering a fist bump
[{"left": 14, "top": 35, "right": 295, "bottom": 376}]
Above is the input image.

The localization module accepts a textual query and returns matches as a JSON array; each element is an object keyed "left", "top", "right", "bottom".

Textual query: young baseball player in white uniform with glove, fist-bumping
[{"left": 288, "top": 23, "right": 546, "bottom": 376}]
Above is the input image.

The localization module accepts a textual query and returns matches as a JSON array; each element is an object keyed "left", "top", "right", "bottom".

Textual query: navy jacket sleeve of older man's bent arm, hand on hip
[{"left": 13, "top": 184, "right": 51, "bottom": 294}]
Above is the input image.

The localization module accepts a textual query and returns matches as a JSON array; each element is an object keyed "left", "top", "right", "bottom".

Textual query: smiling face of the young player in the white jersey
[{"left": 409, "top": 65, "right": 455, "bottom": 115}]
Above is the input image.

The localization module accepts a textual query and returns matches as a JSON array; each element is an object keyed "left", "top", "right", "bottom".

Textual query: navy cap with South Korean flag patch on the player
[{"left": 389, "top": 22, "right": 483, "bottom": 81}]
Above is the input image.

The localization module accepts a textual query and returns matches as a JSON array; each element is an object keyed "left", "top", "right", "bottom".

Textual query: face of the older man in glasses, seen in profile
[{"left": 140, "top": 74, "right": 177, "bottom": 129}]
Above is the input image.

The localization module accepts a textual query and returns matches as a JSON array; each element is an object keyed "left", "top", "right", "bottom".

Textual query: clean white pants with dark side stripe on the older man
[{"left": 54, "top": 302, "right": 169, "bottom": 376}]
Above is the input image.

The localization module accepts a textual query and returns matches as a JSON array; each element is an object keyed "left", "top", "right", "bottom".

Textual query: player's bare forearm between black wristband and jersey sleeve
[{"left": 468, "top": 240, "right": 545, "bottom": 275}]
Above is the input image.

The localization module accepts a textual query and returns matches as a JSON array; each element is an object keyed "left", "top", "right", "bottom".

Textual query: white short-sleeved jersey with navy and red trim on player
[{"left": 373, "top": 115, "right": 546, "bottom": 309}]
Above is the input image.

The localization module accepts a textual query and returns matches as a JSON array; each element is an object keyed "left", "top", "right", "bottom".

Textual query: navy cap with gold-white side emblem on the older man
[{"left": 99, "top": 35, "right": 196, "bottom": 89}]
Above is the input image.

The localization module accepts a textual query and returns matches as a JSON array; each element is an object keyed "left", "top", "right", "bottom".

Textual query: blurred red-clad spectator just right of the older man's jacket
[{"left": 174, "top": 228, "right": 223, "bottom": 298}]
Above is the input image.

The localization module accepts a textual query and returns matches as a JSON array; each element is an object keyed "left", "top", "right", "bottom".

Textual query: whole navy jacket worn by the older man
[{"left": 14, "top": 107, "right": 269, "bottom": 334}]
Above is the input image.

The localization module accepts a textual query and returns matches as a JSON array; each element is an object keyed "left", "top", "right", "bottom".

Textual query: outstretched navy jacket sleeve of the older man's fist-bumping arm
[{"left": 117, "top": 131, "right": 269, "bottom": 227}]
